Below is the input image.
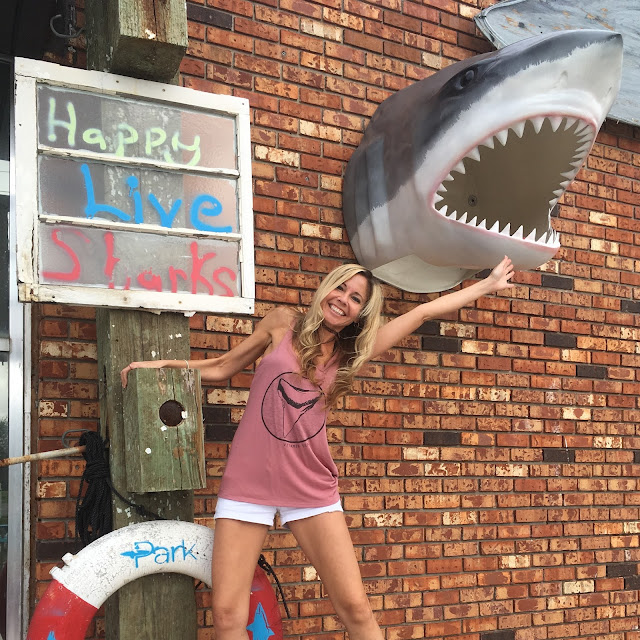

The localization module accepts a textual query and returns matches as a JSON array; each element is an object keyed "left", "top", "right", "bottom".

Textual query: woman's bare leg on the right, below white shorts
[{"left": 289, "top": 511, "right": 383, "bottom": 640}]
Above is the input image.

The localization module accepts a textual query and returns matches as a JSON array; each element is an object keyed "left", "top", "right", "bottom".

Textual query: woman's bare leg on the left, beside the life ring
[{"left": 211, "top": 518, "right": 269, "bottom": 640}]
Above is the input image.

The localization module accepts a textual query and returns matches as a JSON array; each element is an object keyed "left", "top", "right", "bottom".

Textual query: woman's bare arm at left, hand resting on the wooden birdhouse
[{"left": 120, "top": 307, "right": 292, "bottom": 387}]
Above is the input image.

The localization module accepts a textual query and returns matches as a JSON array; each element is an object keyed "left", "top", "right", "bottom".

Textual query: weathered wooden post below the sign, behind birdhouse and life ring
[{"left": 96, "top": 309, "right": 199, "bottom": 640}]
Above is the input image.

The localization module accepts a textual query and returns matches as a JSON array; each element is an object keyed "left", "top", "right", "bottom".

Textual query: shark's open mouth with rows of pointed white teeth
[{"left": 433, "top": 116, "right": 596, "bottom": 246}]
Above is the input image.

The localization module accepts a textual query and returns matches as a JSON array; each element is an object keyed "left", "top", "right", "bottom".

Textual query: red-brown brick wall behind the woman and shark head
[{"left": 34, "top": 0, "right": 640, "bottom": 640}]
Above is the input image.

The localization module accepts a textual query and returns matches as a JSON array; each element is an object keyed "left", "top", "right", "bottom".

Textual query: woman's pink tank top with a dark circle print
[{"left": 218, "top": 331, "right": 340, "bottom": 507}]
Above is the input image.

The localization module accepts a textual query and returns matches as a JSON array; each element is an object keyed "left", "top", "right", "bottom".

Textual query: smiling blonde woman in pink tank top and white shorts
[{"left": 122, "top": 256, "right": 513, "bottom": 640}]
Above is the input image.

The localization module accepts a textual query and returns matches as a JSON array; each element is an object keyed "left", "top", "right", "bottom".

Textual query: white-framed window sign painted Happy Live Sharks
[{"left": 16, "top": 60, "right": 254, "bottom": 312}]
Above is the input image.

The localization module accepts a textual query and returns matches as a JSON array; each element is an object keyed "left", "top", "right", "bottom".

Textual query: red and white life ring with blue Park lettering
[{"left": 26, "top": 520, "right": 282, "bottom": 640}]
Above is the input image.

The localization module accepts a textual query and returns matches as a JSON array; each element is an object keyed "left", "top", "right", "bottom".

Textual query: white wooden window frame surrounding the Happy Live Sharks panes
[{"left": 15, "top": 58, "right": 255, "bottom": 315}]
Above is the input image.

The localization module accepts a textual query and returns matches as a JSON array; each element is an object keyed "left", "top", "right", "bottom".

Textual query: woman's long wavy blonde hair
[{"left": 293, "top": 264, "right": 383, "bottom": 406}]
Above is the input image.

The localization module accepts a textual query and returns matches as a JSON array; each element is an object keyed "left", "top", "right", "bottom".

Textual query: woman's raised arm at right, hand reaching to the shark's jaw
[{"left": 371, "top": 256, "right": 514, "bottom": 358}]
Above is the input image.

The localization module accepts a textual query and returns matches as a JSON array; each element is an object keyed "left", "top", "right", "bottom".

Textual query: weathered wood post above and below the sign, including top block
[{"left": 86, "top": 0, "right": 200, "bottom": 640}]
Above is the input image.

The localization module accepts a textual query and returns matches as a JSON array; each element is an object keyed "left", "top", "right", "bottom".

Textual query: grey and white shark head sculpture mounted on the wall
[{"left": 343, "top": 30, "right": 622, "bottom": 293}]
